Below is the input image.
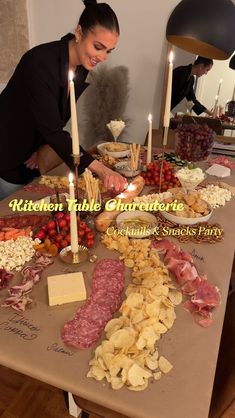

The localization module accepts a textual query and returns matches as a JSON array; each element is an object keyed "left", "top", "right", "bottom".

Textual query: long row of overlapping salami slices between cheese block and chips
[{"left": 61, "top": 259, "right": 124, "bottom": 349}]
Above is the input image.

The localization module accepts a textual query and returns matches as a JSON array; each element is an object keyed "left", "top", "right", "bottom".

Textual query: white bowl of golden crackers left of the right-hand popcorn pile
[{"left": 161, "top": 188, "right": 212, "bottom": 225}]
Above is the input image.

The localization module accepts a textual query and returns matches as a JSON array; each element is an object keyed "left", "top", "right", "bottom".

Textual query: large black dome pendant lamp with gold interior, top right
[{"left": 166, "top": 0, "right": 235, "bottom": 60}]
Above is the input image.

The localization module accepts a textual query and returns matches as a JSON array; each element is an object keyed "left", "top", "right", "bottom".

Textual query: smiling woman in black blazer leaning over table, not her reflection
[{"left": 0, "top": 0, "right": 126, "bottom": 199}]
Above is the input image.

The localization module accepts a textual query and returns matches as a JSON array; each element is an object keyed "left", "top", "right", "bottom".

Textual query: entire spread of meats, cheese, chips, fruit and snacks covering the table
[{"left": 0, "top": 142, "right": 234, "bottom": 404}]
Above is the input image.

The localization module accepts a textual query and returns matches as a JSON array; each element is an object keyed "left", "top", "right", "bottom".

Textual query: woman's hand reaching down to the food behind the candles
[{"left": 88, "top": 160, "right": 127, "bottom": 192}]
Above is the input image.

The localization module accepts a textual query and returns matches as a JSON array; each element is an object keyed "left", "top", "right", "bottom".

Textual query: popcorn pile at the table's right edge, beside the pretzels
[{"left": 198, "top": 184, "right": 232, "bottom": 208}]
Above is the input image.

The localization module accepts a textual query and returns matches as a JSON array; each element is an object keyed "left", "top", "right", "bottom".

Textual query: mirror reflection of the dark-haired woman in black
[{"left": 171, "top": 57, "right": 213, "bottom": 116}]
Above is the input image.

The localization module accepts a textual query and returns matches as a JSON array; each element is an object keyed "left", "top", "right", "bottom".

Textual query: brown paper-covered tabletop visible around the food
[{"left": 0, "top": 161, "right": 235, "bottom": 418}]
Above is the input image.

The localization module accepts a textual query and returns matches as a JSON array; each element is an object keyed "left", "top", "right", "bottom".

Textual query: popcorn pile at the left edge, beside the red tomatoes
[{"left": 0, "top": 237, "right": 35, "bottom": 271}]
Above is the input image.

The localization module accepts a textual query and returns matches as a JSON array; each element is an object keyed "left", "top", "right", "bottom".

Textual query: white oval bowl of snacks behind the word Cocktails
[{"left": 116, "top": 210, "right": 157, "bottom": 238}]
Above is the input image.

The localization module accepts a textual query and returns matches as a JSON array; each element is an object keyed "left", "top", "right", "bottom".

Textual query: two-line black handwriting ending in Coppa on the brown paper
[{"left": 0, "top": 313, "right": 40, "bottom": 341}]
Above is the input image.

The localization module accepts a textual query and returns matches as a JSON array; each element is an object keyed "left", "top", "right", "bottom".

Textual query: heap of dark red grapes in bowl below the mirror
[{"left": 175, "top": 123, "right": 215, "bottom": 161}]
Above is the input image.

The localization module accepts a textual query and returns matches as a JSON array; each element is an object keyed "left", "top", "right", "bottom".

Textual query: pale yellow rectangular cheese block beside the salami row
[{"left": 47, "top": 272, "right": 87, "bottom": 306}]
